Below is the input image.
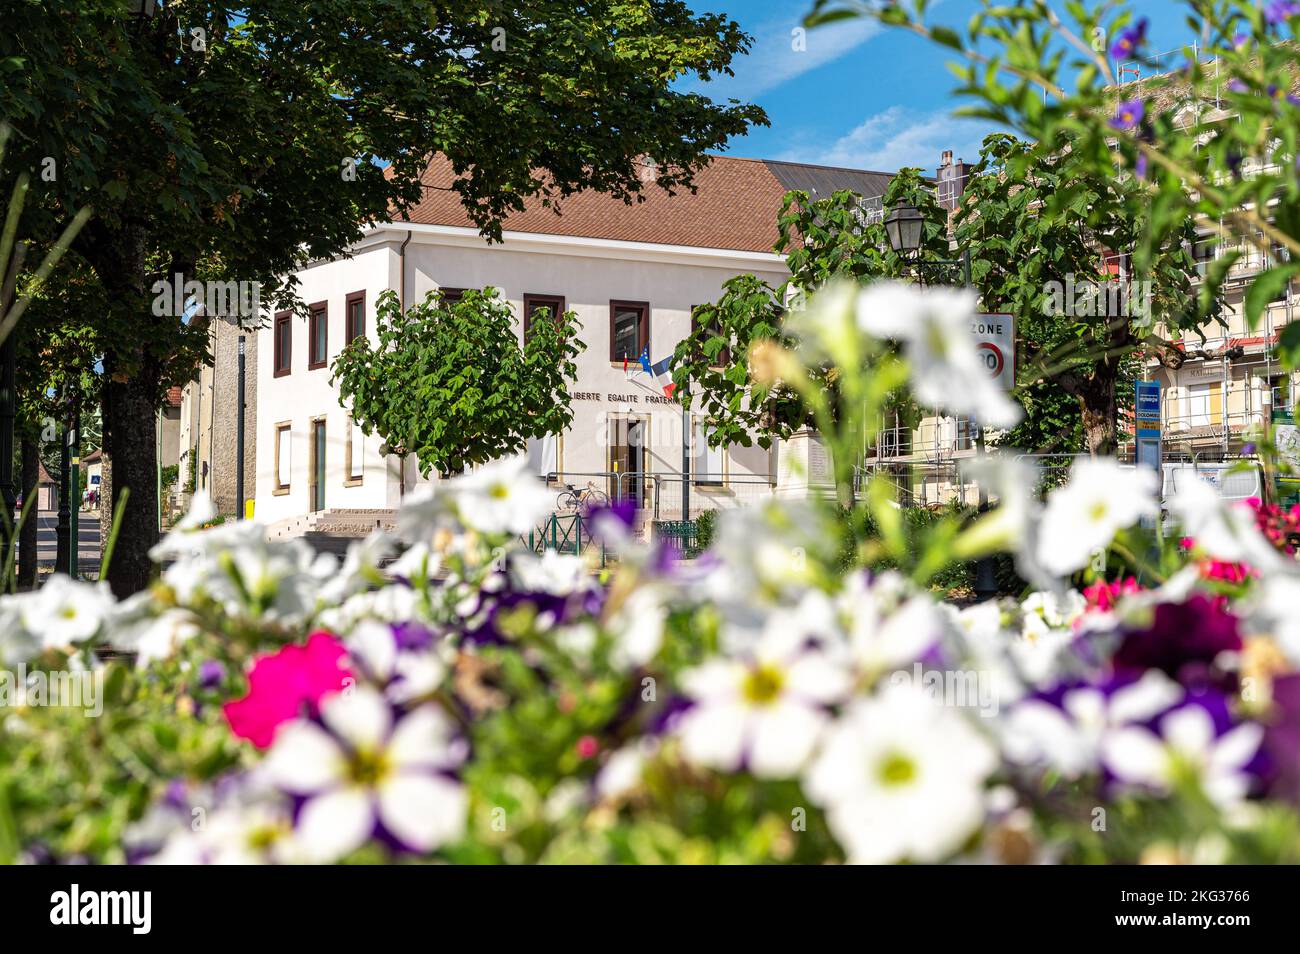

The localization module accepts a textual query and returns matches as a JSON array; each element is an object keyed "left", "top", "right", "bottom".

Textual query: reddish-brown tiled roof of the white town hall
[{"left": 384, "top": 155, "right": 891, "bottom": 252}]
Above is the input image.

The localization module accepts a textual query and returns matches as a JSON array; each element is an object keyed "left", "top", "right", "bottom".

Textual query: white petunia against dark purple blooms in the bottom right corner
[{"left": 1101, "top": 704, "right": 1264, "bottom": 808}]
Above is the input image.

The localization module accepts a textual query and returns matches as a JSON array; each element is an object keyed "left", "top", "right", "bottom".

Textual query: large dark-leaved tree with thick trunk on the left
[{"left": 0, "top": 0, "right": 766, "bottom": 595}]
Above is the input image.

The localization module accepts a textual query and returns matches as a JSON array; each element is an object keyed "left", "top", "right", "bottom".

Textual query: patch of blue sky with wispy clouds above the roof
[{"left": 692, "top": 0, "right": 1192, "bottom": 172}]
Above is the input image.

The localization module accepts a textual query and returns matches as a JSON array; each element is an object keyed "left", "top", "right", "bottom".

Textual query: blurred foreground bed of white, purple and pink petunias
[{"left": 0, "top": 285, "right": 1300, "bottom": 863}]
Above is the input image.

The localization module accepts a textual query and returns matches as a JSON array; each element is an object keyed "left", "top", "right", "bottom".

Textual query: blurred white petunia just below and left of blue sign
[{"left": 1037, "top": 458, "right": 1158, "bottom": 576}]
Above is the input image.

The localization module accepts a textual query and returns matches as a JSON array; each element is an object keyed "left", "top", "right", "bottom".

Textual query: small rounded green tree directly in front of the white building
[{"left": 330, "top": 289, "right": 582, "bottom": 476}]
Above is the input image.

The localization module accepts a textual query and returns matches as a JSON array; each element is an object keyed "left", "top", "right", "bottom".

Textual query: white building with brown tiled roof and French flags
[{"left": 255, "top": 157, "right": 889, "bottom": 524}]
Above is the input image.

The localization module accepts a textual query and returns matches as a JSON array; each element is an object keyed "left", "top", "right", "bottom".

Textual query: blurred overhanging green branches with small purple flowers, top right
[{"left": 806, "top": 0, "right": 1300, "bottom": 450}]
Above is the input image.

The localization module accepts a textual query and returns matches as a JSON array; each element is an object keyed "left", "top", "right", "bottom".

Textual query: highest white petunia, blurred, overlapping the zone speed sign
[{"left": 858, "top": 282, "right": 1023, "bottom": 428}]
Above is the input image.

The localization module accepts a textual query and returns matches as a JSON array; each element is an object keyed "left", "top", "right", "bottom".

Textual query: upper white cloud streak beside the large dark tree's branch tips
[{"left": 684, "top": 17, "right": 880, "bottom": 100}]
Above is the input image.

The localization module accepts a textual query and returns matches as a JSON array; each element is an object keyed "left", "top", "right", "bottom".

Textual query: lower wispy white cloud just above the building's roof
[{"left": 781, "top": 107, "right": 993, "bottom": 172}]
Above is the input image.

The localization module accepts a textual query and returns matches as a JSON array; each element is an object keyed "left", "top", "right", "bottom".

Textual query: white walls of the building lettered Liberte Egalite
[{"left": 256, "top": 226, "right": 785, "bottom": 522}]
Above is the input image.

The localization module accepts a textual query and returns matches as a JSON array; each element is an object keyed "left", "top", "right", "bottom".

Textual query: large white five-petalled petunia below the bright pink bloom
[{"left": 265, "top": 686, "right": 467, "bottom": 862}]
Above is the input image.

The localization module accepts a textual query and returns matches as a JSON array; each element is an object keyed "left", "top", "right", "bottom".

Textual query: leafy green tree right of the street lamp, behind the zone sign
[{"left": 956, "top": 134, "right": 1218, "bottom": 455}]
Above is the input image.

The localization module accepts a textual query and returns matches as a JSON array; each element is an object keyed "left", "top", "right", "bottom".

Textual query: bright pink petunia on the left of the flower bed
[{"left": 222, "top": 632, "right": 352, "bottom": 749}]
